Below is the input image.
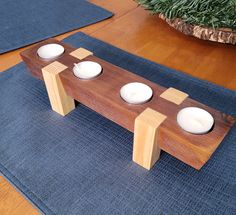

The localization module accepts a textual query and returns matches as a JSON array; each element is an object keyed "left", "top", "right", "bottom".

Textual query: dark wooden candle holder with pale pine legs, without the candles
[{"left": 21, "top": 39, "right": 235, "bottom": 169}]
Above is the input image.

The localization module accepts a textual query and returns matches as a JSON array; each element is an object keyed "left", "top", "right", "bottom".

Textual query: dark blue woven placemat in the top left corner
[{"left": 0, "top": 0, "right": 112, "bottom": 54}]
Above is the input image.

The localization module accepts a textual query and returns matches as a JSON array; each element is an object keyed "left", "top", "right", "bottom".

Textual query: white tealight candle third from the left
[{"left": 120, "top": 82, "right": 153, "bottom": 104}]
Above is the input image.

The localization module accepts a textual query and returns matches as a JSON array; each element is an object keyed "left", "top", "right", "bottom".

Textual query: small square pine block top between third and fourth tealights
[{"left": 160, "top": 87, "right": 188, "bottom": 105}]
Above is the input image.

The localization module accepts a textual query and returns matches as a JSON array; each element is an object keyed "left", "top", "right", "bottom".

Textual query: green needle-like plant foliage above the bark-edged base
[{"left": 136, "top": 0, "right": 236, "bottom": 30}]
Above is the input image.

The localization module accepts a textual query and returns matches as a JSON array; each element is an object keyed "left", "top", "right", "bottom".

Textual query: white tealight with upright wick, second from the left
[{"left": 73, "top": 61, "right": 102, "bottom": 79}]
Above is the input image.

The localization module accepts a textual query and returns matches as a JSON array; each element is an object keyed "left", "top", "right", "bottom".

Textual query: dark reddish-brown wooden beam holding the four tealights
[{"left": 22, "top": 39, "right": 235, "bottom": 169}]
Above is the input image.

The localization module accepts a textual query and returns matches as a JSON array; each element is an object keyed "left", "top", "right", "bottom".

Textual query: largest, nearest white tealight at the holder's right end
[{"left": 177, "top": 107, "right": 214, "bottom": 134}]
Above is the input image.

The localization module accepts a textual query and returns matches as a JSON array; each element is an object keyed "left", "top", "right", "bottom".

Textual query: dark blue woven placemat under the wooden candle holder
[{"left": 0, "top": 33, "right": 236, "bottom": 215}]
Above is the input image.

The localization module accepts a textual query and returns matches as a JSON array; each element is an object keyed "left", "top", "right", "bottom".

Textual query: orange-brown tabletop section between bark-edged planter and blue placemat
[{"left": 90, "top": 7, "right": 236, "bottom": 90}]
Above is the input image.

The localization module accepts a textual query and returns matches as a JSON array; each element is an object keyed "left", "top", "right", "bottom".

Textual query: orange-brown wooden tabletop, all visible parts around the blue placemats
[{"left": 0, "top": 0, "right": 236, "bottom": 215}]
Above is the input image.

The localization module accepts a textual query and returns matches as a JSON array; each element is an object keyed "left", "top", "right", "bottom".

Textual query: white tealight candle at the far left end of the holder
[{"left": 37, "top": 43, "right": 65, "bottom": 60}]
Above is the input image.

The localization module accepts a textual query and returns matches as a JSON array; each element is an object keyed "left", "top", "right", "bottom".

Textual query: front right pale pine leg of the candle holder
[{"left": 133, "top": 108, "right": 166, "bottom": 170}]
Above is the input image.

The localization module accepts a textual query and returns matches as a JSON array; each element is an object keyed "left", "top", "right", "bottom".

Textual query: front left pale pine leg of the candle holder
[{"left": 42, "top": 61, "right": 75, "bottom": 116}]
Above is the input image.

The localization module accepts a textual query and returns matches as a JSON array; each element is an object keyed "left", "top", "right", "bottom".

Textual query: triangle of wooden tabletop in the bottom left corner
[{"left": 0, "top": 176, "right": 40, "bottom": 215}]
